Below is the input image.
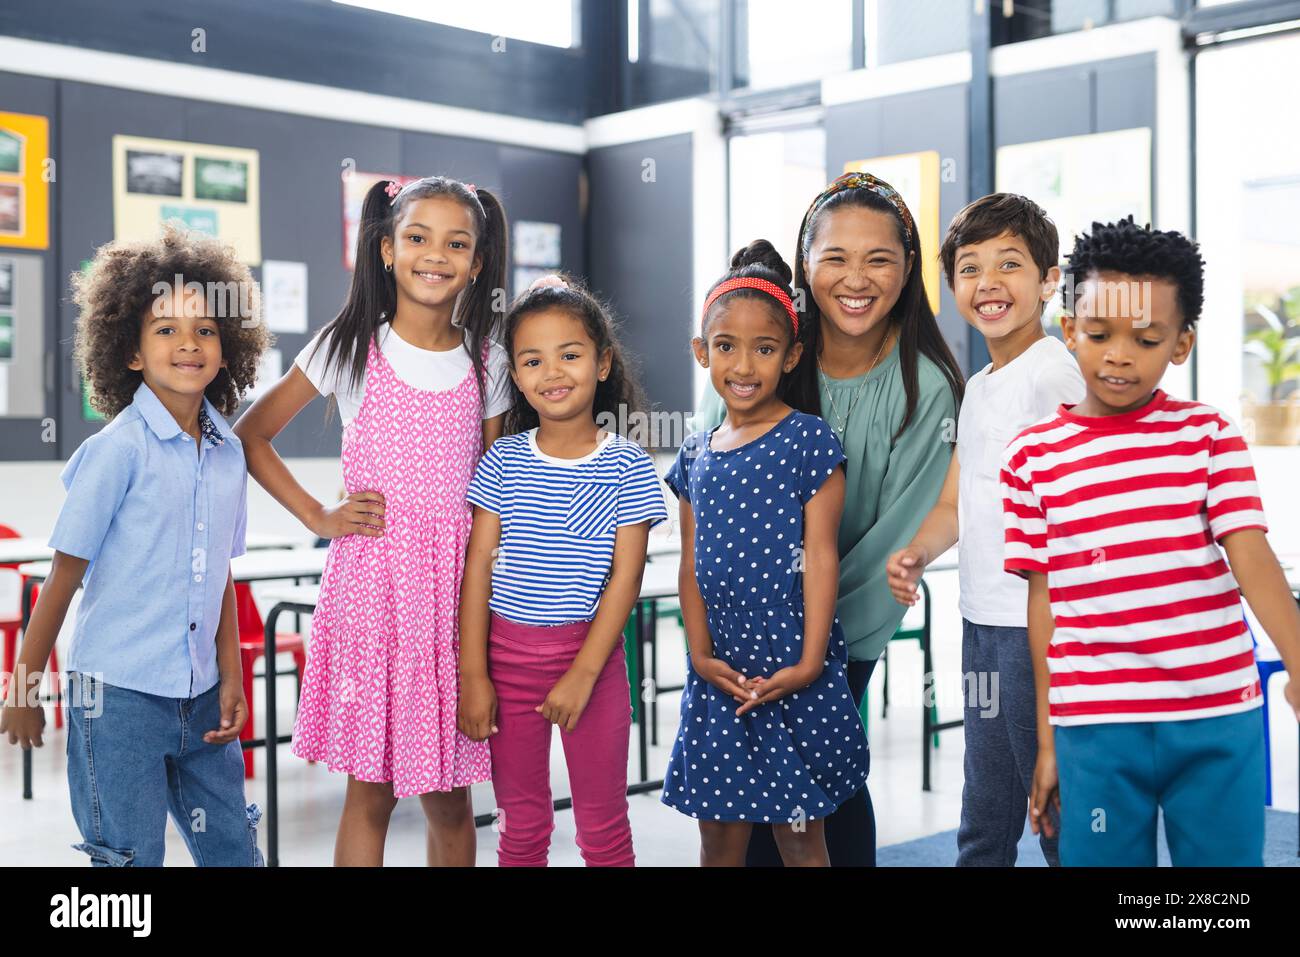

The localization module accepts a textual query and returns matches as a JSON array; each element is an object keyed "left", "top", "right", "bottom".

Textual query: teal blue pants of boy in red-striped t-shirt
[{"left": 1056, "top": 709, "right": 1265, "bottom": 867}]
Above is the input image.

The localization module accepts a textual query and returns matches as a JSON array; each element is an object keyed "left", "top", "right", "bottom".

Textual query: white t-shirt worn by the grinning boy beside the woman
[{"left": 957, "top": 335, "right": 1084, "bottom": 628}]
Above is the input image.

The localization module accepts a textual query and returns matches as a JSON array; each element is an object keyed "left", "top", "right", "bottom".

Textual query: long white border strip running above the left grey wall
[{"left": 0, "top": 36, "right": 586, "bottom": 153}]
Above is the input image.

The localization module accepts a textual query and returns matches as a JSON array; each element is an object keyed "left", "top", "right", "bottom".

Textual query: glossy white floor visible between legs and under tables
[{"left": 0, "top": 566, "right": 1296, "bottom": 866}]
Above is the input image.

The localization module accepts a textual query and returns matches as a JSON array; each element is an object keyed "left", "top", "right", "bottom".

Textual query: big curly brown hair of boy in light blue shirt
[{"left": 72, "top": 224, "right": 272, "bottom": 419}]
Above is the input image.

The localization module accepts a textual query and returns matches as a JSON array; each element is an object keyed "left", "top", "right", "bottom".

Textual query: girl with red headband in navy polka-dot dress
[{"left": 663, "top": 239, "right": 867, "bottom": 866}]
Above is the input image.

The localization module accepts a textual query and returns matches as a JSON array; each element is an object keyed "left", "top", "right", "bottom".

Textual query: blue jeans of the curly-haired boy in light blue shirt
[{"left": 68, "top": 674, "right": 263, "bottom": 867}]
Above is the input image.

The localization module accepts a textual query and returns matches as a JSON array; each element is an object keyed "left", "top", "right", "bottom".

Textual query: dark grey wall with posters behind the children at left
[{"left": 0, "top": 73, "right": 585, "bottom": 459}]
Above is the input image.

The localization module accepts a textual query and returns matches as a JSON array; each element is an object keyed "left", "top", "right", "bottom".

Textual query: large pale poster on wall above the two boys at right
[{"left": 997, "top": 126, "right": 1151, "bottom": 326}]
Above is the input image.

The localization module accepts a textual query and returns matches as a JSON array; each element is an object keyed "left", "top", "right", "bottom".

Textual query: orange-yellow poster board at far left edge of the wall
[{"left": 0, "top": 113, "right": 49, "bottom": 250}]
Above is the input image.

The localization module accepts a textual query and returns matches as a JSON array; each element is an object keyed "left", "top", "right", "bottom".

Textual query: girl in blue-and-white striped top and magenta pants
[{"left": 459, "top": 281, "right": 667, "bottom": 867}]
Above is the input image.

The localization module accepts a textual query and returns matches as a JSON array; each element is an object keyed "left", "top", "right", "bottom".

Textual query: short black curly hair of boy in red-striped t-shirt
[{"left": 1062, "top": 216, "right": 1205, "bottom": 329}]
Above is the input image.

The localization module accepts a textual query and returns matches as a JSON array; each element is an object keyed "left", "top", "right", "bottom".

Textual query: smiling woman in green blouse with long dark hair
[{"left": 696, "top": 173, "right": 962, "bottom": 866}]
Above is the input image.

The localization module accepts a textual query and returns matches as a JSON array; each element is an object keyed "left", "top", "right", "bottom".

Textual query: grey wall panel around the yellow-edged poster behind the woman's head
[{"left": 826, "top": 85, "right": 970, "bottom": 368}]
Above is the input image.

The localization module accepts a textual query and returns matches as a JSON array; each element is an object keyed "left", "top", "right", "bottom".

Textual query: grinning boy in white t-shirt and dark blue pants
[{"left": 887, "top": 192, "right": 1083, "bottom": 867}]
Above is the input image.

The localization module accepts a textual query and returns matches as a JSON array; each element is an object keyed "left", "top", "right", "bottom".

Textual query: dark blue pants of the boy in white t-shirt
[{"left": 957, "top": 619, "right": 1058, "bottom": 867}]
